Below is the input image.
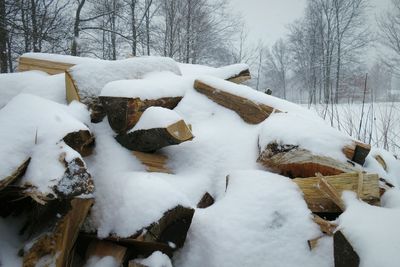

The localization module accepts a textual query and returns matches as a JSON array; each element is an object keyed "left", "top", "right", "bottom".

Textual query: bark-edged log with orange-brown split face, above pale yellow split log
[{"left": 257, "top": 142, "right": 357, "bottom": 178}]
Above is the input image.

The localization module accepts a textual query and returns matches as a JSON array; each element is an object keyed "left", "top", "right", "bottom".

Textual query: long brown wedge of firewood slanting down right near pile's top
[{"left": 194, "top": 80, "right": 280, "bottom": 124}]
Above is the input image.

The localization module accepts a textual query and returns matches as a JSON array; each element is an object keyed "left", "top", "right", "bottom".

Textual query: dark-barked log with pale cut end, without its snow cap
[{"left": 116, "top": 120, "right": 193, "bottom": 152}]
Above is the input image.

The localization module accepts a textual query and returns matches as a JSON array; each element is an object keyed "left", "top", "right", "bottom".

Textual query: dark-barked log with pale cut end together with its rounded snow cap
[{"left": 116, "top": 107, "right": 193, "bottom": 152}]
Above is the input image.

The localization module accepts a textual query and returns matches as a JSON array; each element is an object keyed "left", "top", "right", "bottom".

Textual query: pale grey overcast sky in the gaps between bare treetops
[{"left": 229, "top": 0, "right": 390, "bottom": 45}]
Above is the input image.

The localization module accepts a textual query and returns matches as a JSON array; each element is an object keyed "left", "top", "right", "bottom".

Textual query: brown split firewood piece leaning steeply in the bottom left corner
[{"left": 23, "top": 198, "right": 93, "bottom": 267}]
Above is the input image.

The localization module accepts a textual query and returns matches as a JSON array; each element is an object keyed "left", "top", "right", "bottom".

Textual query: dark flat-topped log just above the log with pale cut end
[{"left": 99, "top": 96, "right": 182, "bottom": 134}]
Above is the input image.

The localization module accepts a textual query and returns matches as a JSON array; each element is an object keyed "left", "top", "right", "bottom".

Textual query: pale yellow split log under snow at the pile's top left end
[{"left": 18, "top": 56, "right": 75, "bottom": 75}]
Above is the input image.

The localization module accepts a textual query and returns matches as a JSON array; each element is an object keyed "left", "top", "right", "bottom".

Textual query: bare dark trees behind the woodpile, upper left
[{"left": 0, "top": 0, "right": 240, "bottom": 72}]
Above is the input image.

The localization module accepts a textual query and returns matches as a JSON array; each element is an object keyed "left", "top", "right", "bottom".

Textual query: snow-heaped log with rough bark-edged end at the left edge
[{"left": 0, "top": 94, "right": 93, "bottom": 201}]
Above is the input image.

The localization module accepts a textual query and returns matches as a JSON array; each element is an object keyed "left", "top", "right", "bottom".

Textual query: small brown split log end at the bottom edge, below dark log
[{"left": 86, "top": 240, "right": 127, "bottom": 266}]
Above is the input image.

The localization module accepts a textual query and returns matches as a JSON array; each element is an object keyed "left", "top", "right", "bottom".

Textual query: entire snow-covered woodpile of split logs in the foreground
[{"left": 0, "top": 54, "right": 400, "bottom": 267}]
